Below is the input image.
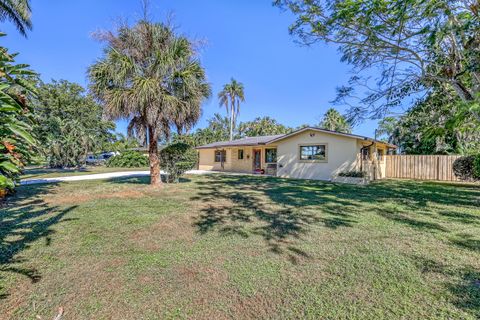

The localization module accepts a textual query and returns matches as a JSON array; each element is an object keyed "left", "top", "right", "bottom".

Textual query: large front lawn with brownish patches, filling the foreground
[{"left": 0, "top": 175, "right": 480, "bottom": 320}]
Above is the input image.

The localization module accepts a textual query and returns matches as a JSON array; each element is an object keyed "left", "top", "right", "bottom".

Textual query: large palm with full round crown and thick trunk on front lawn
[{"left": 89, "top": 20, "right": 210, "bottom": 185}]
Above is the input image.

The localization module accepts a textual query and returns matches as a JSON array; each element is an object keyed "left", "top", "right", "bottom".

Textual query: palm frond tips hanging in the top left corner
[{"left": 0, "top": 0, "right": 32, "bottom": 36}]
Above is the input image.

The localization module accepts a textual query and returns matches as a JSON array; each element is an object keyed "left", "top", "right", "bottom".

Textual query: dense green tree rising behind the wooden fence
[{"left": 379, "top": 90, "right": 480, "bottom": 154}]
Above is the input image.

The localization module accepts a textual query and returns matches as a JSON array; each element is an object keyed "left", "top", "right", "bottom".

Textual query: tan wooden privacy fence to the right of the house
[{"left": 385, "top": 155, "right": 460, "bottom": 181}]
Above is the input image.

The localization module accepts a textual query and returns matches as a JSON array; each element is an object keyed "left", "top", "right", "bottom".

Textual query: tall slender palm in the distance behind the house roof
[{"left": 218, "top": 78, "right": 245, "bottom": 141}]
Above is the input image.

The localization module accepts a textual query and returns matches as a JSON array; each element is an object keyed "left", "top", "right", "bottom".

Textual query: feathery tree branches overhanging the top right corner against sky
[{"left": 274, "top": 0, "right": 480, "bottom": 119}]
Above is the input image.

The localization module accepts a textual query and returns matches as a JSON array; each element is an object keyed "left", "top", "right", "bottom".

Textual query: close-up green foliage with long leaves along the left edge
[{"left": 0, "top": 34, "right": 36, "bottom": 195}]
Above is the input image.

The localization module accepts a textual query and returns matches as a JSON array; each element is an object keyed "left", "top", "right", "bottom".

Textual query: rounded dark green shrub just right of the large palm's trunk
[{"left": 160, "top": 142, "right": 198, "bottom": 182}]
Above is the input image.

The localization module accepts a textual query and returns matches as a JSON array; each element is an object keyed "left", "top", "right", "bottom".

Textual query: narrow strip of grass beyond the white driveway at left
[{"left": 21, "top": 166, "right": 149, "bottom": 179}]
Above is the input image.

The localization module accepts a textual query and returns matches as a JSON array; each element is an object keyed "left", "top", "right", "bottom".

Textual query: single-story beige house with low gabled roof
[{"left": 197, "top": 127, "right": 396, "bottom": 180}]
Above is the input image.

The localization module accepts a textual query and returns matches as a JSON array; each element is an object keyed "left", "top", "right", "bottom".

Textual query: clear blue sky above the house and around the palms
[{"left": 1, "top": 0, "right": 377, "bottom": 136}]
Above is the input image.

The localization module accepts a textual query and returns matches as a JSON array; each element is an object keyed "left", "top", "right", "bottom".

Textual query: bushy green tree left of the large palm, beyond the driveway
[{"left": 33, "top": 80, "right": 115, "bottom": 167}]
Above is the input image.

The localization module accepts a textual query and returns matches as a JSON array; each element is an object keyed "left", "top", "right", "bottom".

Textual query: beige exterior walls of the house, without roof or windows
[{"left": 199, "top": 130, "right": 388, "bottom": 180}]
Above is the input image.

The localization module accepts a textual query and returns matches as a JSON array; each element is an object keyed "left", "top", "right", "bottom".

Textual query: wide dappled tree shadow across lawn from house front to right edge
[{"left": 191, "top": 175, "right": 480, "bottom": 262}]
